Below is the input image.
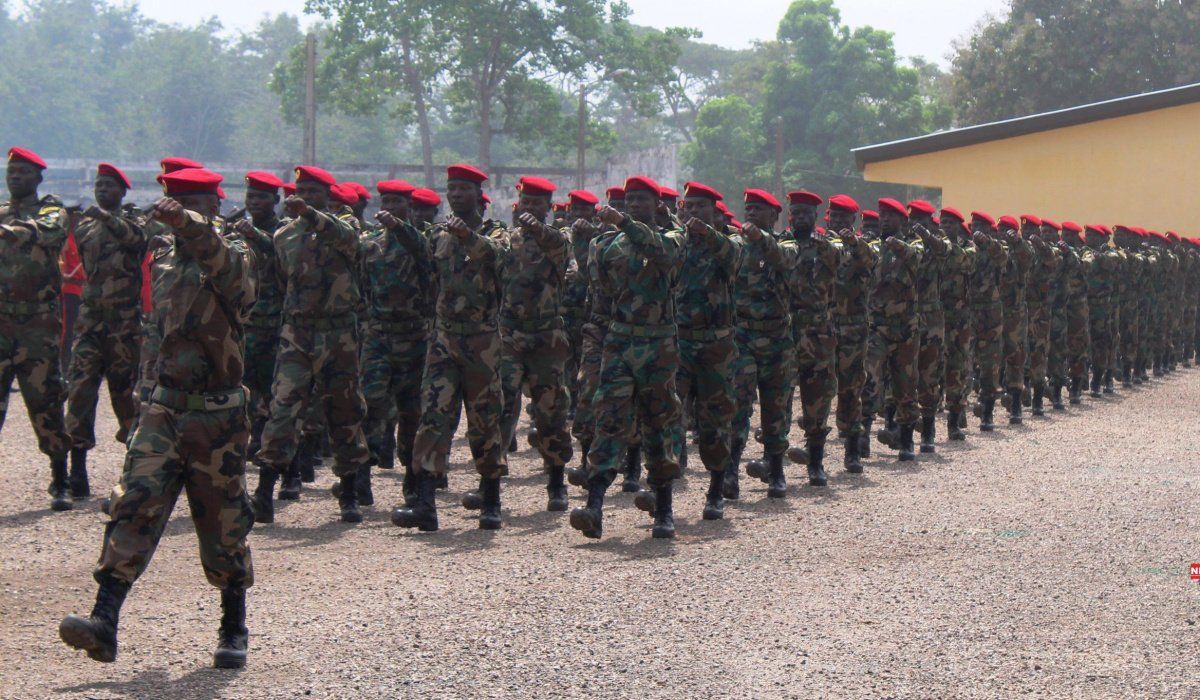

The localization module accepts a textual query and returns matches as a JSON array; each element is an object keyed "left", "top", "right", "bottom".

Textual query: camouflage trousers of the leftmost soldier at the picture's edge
[{"left": 0, "top": 306, "right": 71, "bottom": 457}]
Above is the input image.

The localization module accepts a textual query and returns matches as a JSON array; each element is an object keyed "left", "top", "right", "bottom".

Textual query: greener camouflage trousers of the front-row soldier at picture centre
[{"left": 588, "top": 331, "right": 683, "bottom": 485}]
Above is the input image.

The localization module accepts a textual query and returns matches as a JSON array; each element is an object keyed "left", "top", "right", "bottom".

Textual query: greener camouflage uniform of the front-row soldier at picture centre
[{"left": 588, "top": 220, "right": 683, "bottom": 486}]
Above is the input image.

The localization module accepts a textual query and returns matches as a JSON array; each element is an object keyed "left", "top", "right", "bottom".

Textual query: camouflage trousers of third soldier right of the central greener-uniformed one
[{"left": 792, "top": 317, "right": 838, "bottom": 438}]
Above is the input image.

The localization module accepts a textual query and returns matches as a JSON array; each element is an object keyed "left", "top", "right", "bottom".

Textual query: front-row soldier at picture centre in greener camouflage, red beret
[{"left": 571, "top": 175, "right": 683, "bottom": 538}]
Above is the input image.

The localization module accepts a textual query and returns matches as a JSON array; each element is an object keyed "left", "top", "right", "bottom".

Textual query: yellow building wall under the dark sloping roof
[{"left": 863, "top": 103, "right": 1200, "bottom": 235}]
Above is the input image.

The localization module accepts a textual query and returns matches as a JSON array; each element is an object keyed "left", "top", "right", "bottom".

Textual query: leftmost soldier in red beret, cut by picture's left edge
[{"left": 0, "top": 148, "right": 72, "bottom": 510}]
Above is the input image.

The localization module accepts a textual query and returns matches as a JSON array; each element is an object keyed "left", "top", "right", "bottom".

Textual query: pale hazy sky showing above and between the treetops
[{"left": 117, "top": 0, "right": 1008, "bottom": 65}]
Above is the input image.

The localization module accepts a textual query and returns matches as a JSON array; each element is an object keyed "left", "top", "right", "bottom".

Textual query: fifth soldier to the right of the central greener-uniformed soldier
[{"left": 866, "top": 198, "right": 922, "bottom": 461}]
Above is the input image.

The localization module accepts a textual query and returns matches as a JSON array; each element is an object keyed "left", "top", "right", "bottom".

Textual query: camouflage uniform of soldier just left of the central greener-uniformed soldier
[{"left": 499, "top": 226, "right": 571, "bottom": 468}]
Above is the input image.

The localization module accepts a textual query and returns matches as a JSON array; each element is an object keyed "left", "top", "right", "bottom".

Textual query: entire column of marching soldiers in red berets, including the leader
[{"left": 0, "top": 148, "right": 1200, "bottom": 666}]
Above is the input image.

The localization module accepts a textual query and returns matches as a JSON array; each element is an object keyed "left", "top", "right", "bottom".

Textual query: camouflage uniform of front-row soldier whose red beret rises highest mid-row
[{"left": 413, "top": 220, "right": 509, "bottom": 479}]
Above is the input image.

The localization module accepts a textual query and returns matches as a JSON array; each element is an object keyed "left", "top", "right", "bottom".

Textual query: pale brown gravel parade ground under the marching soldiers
[{"left": 0, "top": 370, "right": 1200, "bottom": 699}]
